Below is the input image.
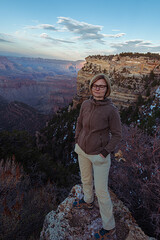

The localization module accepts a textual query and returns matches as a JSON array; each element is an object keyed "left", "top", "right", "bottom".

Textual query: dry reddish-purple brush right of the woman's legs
[{"left": 110, "top": 124, "right": 160, "bottom": 238}]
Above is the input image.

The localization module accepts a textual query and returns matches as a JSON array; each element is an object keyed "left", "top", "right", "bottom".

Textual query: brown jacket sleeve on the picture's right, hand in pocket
[{"left": 101, "top": 108, "right": 122, "bottom": 157}]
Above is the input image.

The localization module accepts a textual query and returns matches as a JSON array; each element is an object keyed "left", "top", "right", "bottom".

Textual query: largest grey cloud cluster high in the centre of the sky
[{"left": 25, "top": 17, "right": 125, "bottom": 44}]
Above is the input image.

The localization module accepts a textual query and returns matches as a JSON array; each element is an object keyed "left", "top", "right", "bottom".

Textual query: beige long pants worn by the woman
[{"left": 75, "top": 144, "right": 115, "bottom": 230}]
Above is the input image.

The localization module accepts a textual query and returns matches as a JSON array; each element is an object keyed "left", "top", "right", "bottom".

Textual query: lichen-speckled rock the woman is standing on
[{"left": 40, "top": 185, "right": 154, "bottom": 240}]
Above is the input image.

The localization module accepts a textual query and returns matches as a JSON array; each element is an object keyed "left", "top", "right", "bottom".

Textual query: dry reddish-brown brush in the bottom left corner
[{"left": 0, "top": 156, "right": 57, "bottom": 240}]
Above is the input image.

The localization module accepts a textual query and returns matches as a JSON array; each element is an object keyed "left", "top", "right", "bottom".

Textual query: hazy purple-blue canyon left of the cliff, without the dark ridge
[{"left": 0, "top": 56, "right": 83, "bottom": 114}]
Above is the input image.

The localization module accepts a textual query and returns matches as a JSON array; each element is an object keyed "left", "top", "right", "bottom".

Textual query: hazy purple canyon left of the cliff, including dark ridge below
[{"left": 0, "top": 56, "right": 83, "bottom": 131}]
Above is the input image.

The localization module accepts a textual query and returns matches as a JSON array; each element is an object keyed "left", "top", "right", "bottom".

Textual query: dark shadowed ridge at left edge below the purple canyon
[{"left": 0, "top": 96, "right": 49, "bottom": 134}]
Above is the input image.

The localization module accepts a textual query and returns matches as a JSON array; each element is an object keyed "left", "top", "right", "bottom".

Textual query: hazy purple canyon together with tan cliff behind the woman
[{"left": 0, "top": 53, "right": 160, "bottom": 114}]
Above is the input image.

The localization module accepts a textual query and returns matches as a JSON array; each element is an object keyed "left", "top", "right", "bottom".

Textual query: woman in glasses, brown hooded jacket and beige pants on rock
[{"left": 73, "top": 73, "right": 121, "bottom": 239}]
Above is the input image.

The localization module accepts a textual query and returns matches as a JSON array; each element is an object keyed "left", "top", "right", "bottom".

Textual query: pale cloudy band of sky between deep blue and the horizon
[{"left": 0, "top": 16, "right": 160, "bottom": 60}]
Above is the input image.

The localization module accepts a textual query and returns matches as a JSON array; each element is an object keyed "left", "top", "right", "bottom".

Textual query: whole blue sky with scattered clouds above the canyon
[{"left": 0, "top": 0, "right": 160, "bottom": 60}]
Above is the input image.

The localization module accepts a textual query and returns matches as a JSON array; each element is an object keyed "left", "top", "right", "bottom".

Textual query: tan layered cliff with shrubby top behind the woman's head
[{"left": 73, "top": 54, "right": 160, "bottom": 107}]
